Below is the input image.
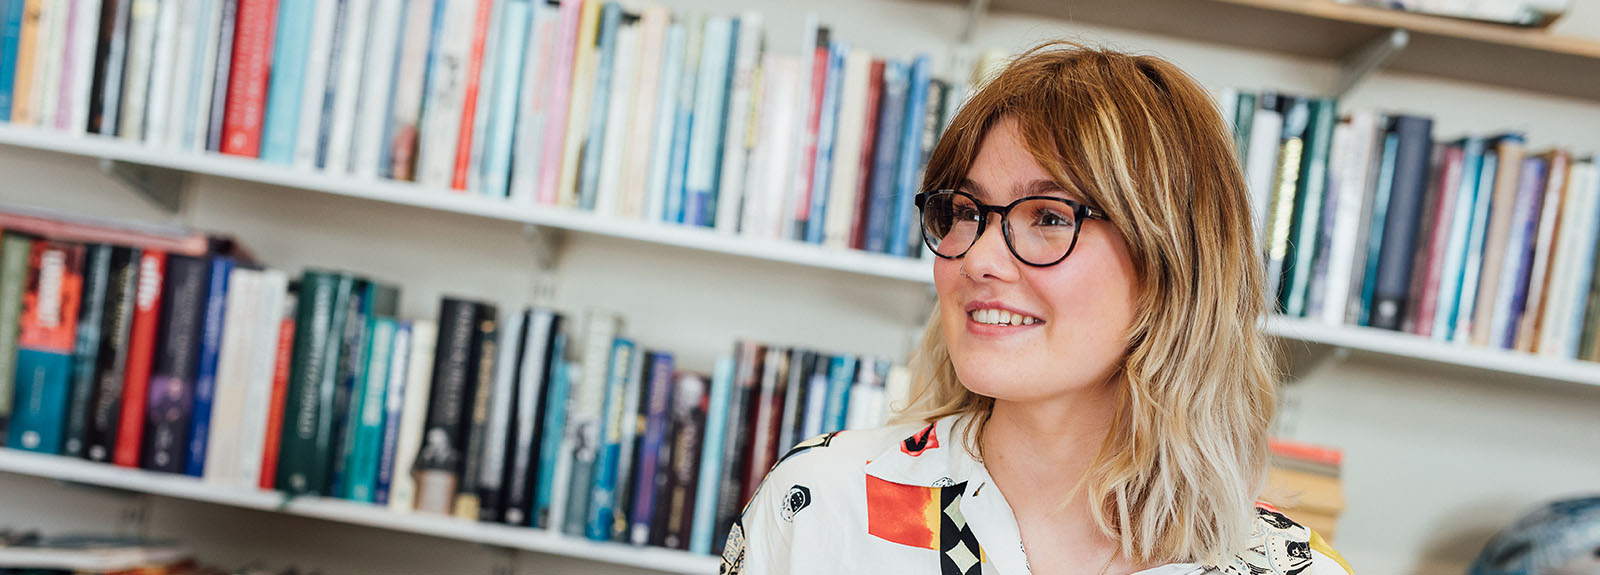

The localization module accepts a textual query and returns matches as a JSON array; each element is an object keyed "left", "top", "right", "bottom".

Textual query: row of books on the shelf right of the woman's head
[{"left": 1222, "top": 91, "right": 1600, "bottom": 359}]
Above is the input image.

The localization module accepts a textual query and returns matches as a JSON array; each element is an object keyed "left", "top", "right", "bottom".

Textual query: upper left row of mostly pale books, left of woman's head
[{"left": 0, "top": 0, "right": 994, "bottom": 258}]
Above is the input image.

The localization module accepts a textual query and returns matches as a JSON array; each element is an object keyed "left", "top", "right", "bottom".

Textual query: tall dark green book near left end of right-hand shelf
[{"left": 1282, "top": 98, "right": 1339, "bottom": 317}]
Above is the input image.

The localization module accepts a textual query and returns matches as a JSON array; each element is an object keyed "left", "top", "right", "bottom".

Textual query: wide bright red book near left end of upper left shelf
[{"left": 222, "top": 0, "right": 278, "bottom": 157}]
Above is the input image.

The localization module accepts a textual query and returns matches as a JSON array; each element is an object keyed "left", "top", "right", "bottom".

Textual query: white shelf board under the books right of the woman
[{"left": 1266, "top": 317, "right": 1600, "bottom": 386}]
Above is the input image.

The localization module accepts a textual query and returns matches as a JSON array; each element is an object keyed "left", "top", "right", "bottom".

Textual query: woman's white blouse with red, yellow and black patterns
[{"left": 722, "top": 416, "right": 1350, "bottom": 575}]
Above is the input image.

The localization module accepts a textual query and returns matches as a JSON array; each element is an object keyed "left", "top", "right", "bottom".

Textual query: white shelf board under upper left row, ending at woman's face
[{"left": 0, "top": 123, "right": 933, "bottom": 283}]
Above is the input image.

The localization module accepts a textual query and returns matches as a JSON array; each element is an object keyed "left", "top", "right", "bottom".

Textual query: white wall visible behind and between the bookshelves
[{"left": 0, "top": 0, "right": 1600, "bottom": 573}]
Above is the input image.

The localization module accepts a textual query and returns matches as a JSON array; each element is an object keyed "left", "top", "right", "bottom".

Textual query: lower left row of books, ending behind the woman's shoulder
[{"left": 0, "top": 206, "right": 909, "bottom": 553}]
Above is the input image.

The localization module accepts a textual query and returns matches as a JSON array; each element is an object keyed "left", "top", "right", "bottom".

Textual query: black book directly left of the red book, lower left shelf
[{"left": 83, "top": 247, "right": 141, "bottom": 461}]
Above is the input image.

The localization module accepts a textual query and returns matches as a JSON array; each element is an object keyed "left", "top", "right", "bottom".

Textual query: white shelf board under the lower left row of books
[{"left": 0, "top": 448, "right": 720, "bottom": 575}]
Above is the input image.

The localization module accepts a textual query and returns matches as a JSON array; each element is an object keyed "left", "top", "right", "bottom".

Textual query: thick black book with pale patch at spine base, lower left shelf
[{"left": 414, "top": 298, "right": 478, "bottom": 514}]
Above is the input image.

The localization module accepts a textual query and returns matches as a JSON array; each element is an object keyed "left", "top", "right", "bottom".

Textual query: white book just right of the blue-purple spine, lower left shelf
[{"left": 205, "top": 267, "right": 261, "bottom": 485}]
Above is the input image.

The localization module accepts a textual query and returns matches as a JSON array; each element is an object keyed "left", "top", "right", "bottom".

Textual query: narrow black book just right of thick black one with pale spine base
[{"left": 454, "top": 303, "right": 499, "bottom": 519}]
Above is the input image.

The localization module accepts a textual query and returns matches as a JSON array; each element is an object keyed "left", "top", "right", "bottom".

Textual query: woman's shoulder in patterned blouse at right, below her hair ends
[{"left": 1222, "top": 503, "right": 1354, "bottom": 575}]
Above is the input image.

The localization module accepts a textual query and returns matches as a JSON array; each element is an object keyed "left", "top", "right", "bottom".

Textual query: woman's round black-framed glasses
[{"left": 917, "top": 189, "right": 1107, "bottom": 267}]
